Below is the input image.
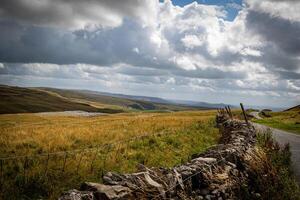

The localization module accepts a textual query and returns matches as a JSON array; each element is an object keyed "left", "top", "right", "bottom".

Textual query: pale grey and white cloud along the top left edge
[{"left": 0, "top": 0, "right": 158, "bottom": 29}]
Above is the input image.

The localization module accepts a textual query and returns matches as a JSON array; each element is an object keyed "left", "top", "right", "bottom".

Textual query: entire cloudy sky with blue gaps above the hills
[{"left": 0, "top": 0, "right": 300, "bottom": 107}]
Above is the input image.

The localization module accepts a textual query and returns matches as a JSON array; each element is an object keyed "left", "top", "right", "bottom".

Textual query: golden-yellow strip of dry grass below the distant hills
[{"left": 0, "top": 111, "right": 215, "bottom": 156}]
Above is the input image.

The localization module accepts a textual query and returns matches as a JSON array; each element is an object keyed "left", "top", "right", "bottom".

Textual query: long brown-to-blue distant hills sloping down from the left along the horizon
[{"left": 0, "top": 85, "right": 232, "bottom": 114}]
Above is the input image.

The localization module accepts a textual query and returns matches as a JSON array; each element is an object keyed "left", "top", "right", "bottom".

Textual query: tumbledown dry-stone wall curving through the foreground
[{"left": 60, "top": 115, "right": 256, "bottom": 200}]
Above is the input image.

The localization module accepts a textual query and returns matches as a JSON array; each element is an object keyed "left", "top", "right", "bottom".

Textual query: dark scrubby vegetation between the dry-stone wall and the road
[{"left": 243, "top": 132, "right": 300, "bottom": 200}]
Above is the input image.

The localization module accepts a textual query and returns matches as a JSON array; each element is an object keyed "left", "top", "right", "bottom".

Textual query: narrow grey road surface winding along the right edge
[{"left": 254, "top": 124, "right": 300, "bottom": 184}]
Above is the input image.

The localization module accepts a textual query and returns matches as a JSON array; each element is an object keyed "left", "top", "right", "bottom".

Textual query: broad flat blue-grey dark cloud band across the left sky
[{"left": 0, "top": 20, "right": 164, "bottom": 66}]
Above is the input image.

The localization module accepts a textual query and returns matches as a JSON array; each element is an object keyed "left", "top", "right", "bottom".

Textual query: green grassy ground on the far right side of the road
[{"left": 253, "top": 110, "right": 300, "bottom": 134}]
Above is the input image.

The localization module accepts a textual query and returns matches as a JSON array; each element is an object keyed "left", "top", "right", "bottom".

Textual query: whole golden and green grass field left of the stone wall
[{"left": 0, "top": 111, "right": 220, "bottom": 199}]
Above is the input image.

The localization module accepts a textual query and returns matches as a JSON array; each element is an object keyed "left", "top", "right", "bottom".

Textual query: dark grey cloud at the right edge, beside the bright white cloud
[{"left": 246, "top": 10, "right": 300, "bottom": 79}]
